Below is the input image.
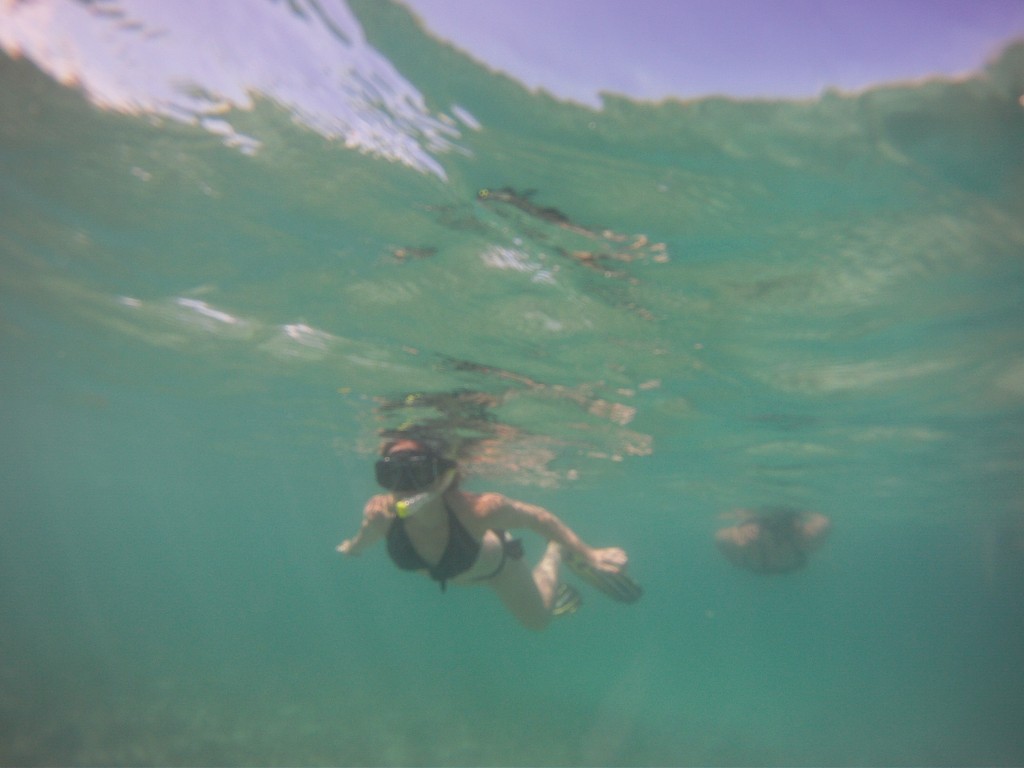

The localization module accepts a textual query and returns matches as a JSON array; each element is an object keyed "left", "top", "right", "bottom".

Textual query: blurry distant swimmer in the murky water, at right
[{"left": 715, "top": 507, "right": 831, "bottom": 573}]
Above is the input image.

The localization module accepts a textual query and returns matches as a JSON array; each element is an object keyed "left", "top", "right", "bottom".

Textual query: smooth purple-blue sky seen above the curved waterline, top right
[{"left": 402, "top": 0, "right": 1024, "bottom": 105}]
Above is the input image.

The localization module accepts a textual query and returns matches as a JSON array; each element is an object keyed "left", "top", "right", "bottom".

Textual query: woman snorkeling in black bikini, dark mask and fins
[{"left": 337, "top": 436, "right": 642, "bottom": 630}]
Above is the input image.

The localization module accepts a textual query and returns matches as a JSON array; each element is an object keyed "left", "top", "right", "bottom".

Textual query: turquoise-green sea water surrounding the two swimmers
[{"left": 0, "top": 3, "right": 1024, "bottom": 765}]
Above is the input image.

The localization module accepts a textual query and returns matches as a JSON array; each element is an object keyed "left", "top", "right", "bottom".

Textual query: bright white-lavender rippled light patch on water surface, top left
[{"left": 0, "top": 0, "right": 464, "bottom": 178}]
